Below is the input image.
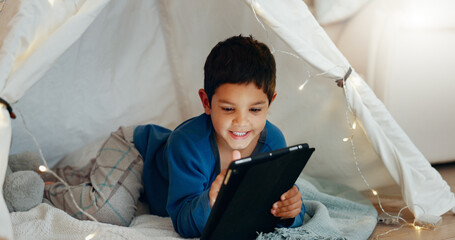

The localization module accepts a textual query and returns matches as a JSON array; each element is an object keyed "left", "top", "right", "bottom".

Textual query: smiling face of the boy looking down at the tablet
[{"left": 199, "top": 83, "right": 276, "bottom": 156}]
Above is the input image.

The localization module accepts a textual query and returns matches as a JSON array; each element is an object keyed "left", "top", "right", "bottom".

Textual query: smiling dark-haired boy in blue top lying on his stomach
[{"left": 43, "top": 35, "right": 305, "bottom": 237}]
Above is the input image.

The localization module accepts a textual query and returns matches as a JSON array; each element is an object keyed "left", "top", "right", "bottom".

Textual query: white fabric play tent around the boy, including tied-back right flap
[{"left": 0, "top": 0, "right": 455, "bottom": 238}]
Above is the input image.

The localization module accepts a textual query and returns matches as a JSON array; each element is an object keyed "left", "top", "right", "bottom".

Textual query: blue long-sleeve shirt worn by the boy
[{"left": 134, "top": 114, "right": 305, "bottom": 237}]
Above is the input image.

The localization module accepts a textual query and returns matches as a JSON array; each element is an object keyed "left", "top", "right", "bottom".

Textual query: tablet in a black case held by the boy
[{"left": 201, "top": 144, "right": 314, "bottom": 239}]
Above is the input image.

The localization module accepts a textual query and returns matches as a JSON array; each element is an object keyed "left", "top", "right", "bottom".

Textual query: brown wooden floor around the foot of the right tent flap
[{"left": 368, "top": 162, "right": 455, "bottom": 240}]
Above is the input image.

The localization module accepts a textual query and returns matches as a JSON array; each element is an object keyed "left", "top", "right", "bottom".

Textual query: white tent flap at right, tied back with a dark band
[{"left": 252, "top": 1, "right": 455, "bottom": 217}]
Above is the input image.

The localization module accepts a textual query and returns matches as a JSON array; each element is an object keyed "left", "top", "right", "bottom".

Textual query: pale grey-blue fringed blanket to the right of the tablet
[{"left": 257, "top": 176, "right": 378, "bottom": 240}]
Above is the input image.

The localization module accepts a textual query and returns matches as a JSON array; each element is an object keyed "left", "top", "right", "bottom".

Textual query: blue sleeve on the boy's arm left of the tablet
[{"left": 166, "top": 132, "right": 216, "bottom": 237}]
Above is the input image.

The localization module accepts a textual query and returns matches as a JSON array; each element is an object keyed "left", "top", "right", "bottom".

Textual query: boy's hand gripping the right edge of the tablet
[{"left": 270, "top": 186, "right": 302, "bottom": 219}]
